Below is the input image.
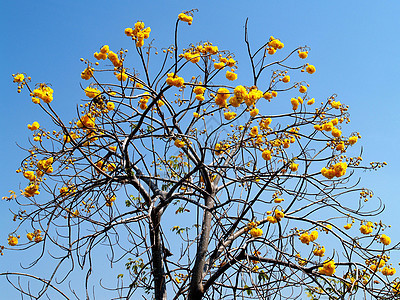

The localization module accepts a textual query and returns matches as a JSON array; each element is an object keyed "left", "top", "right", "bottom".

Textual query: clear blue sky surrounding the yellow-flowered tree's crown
[{"left": 0, "top": 0, "right": 400, "bottom": 299}]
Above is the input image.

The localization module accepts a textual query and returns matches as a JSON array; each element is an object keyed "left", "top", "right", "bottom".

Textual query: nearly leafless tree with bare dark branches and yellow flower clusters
[{"left": 1, "top": 11, "right": 400, "bottom": 299}]
